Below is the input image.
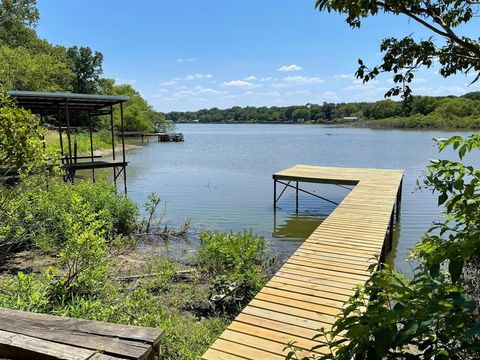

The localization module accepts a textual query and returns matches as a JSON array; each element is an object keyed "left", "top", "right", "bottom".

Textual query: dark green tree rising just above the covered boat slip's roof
[{"left": 67, "top": 46, "right": 103, "bottom": 94}]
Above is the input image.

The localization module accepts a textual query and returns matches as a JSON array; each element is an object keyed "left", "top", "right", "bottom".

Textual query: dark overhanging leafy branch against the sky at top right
[{"left": 316, "top": 0, "right": 480, "bottom": 97}]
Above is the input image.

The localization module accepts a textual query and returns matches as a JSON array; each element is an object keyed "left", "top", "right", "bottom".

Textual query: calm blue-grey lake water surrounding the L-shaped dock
[{"left": 109, "top": 124, "right": 480, "bottom": 272}]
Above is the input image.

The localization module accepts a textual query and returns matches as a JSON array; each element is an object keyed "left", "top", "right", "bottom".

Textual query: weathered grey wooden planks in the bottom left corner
[{"left": 0, "top": 308, "right": 163, "bottom": 360}]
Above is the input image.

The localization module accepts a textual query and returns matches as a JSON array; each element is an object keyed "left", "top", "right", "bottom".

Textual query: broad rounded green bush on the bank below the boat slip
[{"left": 0, "top": 180, "right": 138, "bottom": 250}]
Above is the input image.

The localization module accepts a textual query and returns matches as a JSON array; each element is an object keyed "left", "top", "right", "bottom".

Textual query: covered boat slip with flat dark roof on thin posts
[{"left": 8, "top": 91, "right": 129, "bottom": 192}]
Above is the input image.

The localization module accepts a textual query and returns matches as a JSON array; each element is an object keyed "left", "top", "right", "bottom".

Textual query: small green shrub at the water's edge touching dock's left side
[{"left": 197, "top": 231, "right": 273, "bottom": 315}]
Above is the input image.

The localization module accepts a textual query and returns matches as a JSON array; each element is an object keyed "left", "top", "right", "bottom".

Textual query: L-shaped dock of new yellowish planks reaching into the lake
[{"left": 202, "top": 165, "right": 403, "bottom": 360}]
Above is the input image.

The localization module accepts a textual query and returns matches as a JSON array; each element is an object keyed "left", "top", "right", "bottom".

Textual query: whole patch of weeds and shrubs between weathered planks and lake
[{"left": 0, "top": 179, "right": 271, "bottom": 360}]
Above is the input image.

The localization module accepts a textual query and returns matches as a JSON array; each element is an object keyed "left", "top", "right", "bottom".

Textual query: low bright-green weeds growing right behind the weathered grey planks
[{"left": 0, "top": 253, "right": 227, "bottom": 360}]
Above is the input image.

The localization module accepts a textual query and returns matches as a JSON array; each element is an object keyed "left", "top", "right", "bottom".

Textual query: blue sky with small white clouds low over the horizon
[{"left": 37, "top": 0, "right": 480, "bottom": 111}]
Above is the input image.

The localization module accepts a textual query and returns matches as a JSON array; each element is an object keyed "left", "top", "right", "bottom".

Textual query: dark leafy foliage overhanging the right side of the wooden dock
[{"left": 290, "top": 134, "right": 480, "bottom": 360}]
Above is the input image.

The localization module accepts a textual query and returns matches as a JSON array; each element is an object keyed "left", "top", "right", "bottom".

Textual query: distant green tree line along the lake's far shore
[{"left": 166, "top": 91, "right": 480, "bottom": 127}]
